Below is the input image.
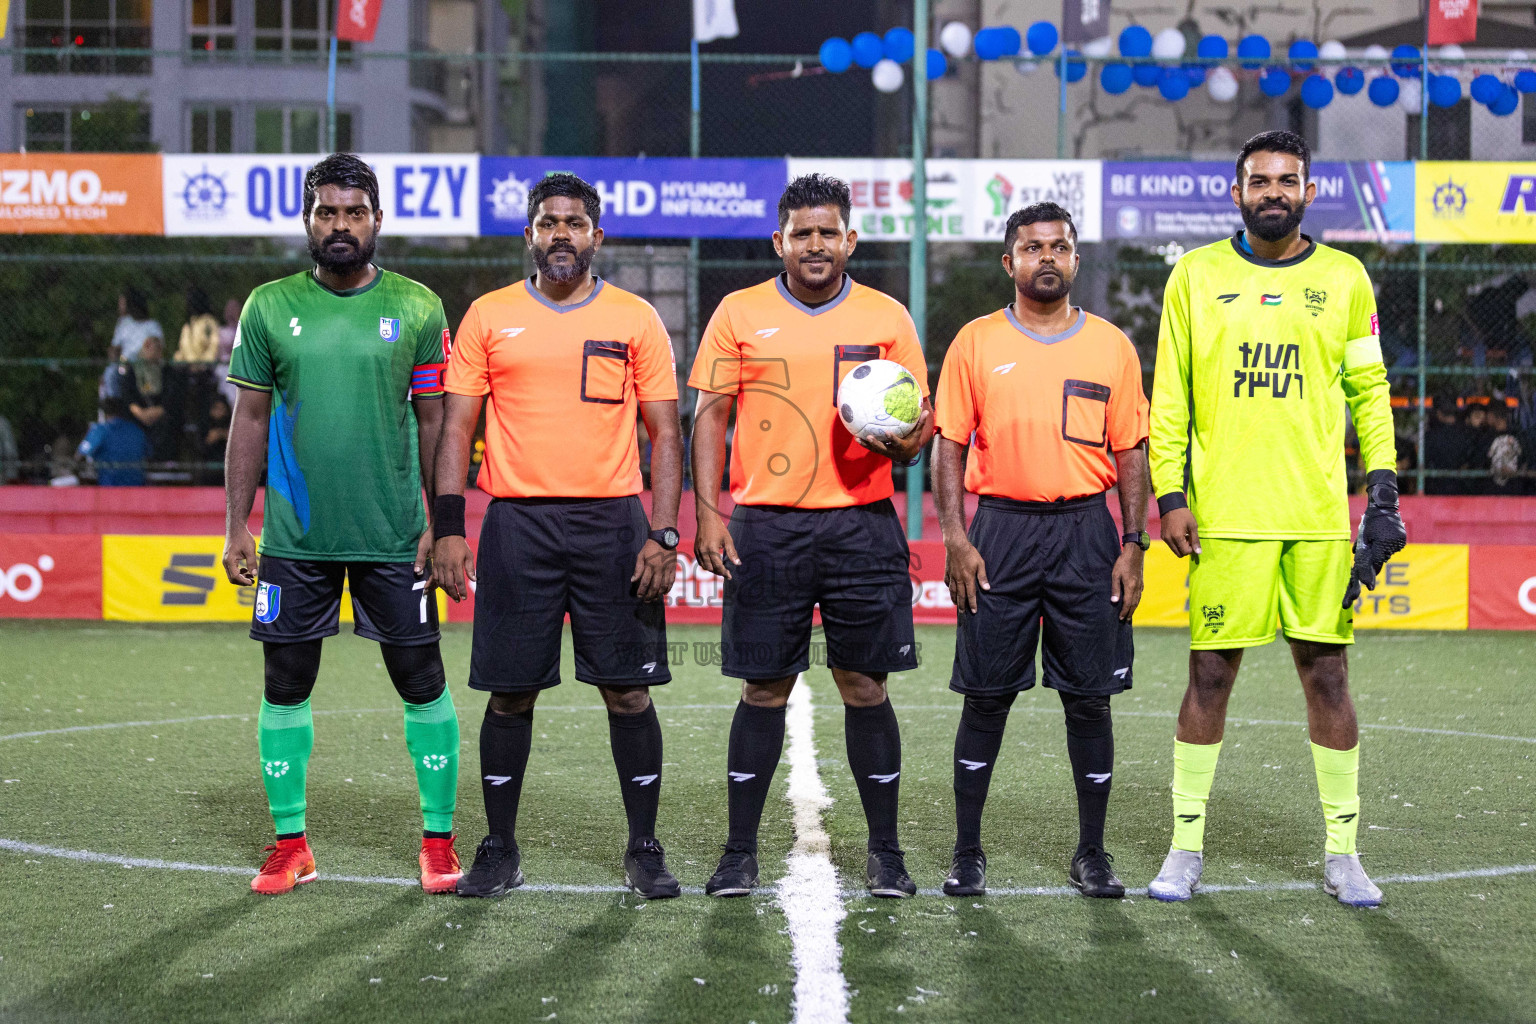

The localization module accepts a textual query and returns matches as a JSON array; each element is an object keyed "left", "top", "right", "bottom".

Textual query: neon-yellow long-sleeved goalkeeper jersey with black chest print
[{"left": 1149, "top": 235, "right": 1396, "bottom": 540}]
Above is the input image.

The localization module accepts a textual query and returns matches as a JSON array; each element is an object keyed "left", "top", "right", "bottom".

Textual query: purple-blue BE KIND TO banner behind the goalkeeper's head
[{"left": 1103, "top": 161, "right": 1415, "bottom": 243}]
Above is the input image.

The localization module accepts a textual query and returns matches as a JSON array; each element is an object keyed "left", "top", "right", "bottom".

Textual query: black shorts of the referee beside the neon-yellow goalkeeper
[{"left": 949, "top": 494, "right": 1134, "bottom": 697}]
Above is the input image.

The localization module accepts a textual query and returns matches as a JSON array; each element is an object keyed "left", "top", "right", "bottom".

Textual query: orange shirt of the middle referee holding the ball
[{"left": 688, "top": 275, "right": 928, "bottom": 508}]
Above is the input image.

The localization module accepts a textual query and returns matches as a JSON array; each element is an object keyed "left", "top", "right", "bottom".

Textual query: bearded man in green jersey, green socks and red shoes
[{"left": 224, "top": 154, "right": 461, "bottom": 894}]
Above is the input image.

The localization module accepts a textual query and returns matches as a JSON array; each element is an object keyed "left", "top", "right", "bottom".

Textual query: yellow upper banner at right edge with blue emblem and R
[{"left": 1413, "top": 160, "right": 1536, "bottom": 243}]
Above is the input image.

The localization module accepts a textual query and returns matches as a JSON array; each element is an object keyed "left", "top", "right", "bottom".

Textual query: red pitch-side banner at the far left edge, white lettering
[{"left": 0, "top": 533, "right": 101, "bottom": 619}]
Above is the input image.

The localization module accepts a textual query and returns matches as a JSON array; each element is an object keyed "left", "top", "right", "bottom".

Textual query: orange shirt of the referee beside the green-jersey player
[{"left": 444, "top": 278, "right": 677, "bottom": 497}]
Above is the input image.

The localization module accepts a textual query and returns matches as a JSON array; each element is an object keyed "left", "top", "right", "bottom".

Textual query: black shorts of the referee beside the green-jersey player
[{"left": 470, "top": 494, "right": 671, "bottom": 692}]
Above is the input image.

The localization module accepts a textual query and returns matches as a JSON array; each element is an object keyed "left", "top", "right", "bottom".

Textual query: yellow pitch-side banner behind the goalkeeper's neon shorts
[{"left": 1137, "top": 543, "right": 1467, "bottom": 629}]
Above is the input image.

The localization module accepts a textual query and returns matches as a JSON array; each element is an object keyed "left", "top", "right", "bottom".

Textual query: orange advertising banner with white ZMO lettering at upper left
[{"left": 0, "top": 154, "right": 163, "bottom": 235}]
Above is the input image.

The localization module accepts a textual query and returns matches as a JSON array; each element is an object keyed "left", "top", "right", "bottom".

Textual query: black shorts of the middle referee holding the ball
[{"left": 720, "top": 499, "right": 917, "bottom": 680}]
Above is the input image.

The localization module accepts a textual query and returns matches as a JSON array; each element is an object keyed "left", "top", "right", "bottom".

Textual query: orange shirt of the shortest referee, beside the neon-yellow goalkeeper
[{"left": 934, "top": 306, "right": 1147, "bottom": 502}]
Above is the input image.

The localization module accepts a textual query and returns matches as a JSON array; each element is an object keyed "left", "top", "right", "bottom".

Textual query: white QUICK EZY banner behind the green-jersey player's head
[{"left": 163, "top": 154, "right": 479, "bottom": 236}]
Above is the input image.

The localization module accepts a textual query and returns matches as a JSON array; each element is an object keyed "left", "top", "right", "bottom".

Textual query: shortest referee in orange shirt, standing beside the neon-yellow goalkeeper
[{"left": 934, "top": 203, "right": 1150, "bottom": 898}]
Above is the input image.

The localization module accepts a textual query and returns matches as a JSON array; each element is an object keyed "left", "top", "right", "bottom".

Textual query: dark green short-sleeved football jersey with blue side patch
[{"left": 229, "top": 270, "right": 449, "bottom": 562}]
